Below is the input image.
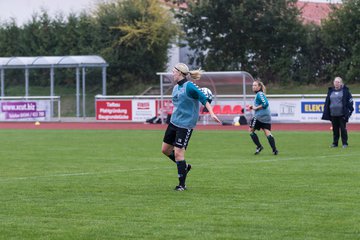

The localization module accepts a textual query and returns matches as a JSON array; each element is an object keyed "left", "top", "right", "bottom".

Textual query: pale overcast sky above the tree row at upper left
[{"left": 0, "top": 0, "right": 98, "bottom": 25}]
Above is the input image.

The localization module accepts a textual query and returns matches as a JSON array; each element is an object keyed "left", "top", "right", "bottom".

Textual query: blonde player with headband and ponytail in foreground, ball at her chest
[{"left": 162, "top": 63, "right": 221, "bottom": 191}]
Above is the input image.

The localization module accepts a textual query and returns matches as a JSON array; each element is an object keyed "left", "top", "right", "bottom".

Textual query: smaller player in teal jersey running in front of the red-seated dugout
[{"left": 249, "top": 80, "right": 279, "bottom": 155}]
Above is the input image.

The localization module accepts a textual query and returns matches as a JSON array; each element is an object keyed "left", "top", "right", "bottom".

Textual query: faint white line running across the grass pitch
[{"left": 0, "top": 153, "right": 358, "bottom": 182}]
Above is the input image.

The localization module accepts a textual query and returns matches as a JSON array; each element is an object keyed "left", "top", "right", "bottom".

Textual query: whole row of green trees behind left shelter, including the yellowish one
[{"left": 0, "top": 0, "right": 178, "bottom": 94}]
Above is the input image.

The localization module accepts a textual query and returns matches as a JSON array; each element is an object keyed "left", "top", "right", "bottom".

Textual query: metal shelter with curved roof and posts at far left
[{"left": 0, "top": 55, "right": 109, "bottom": 117}]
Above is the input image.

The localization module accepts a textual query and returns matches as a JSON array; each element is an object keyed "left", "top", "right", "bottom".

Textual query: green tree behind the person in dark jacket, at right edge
[{"left": 321, "top": 0, "right": 360, "bottom": 82}]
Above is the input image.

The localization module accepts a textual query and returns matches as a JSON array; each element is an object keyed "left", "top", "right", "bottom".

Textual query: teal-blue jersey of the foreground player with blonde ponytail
[{"left": 170, "top": 79, "right": 207, "bottom": 129}]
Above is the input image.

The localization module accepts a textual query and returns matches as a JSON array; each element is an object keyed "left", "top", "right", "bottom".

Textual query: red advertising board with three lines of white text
[{"left": 96, "top": 100, "right": 132, "bottom": 121}]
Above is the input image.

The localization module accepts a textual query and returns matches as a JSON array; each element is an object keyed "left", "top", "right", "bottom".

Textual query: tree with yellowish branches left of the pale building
[{"left": 95, "top": 0, "right": 177, "bottom": 93}]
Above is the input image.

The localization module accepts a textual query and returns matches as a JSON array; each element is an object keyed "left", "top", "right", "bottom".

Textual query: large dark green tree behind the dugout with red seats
[{"left": 179, "top": 0, "right": 305, "bottom": 84}]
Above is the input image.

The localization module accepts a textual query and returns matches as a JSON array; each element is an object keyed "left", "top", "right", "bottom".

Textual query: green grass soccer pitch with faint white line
[{"left": 0, "top": 130, "right": 360, "bottom": 240}]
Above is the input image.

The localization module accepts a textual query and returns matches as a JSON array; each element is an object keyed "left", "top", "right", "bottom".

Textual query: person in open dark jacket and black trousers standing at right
[{"left": 321, "top": 77, "right": 354, "bottom": 148}]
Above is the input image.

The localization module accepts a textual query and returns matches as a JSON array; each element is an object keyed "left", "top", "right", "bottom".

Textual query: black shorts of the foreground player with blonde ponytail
[{"left": 163, "top": 123, "right": 193, "bottom": 149}]
